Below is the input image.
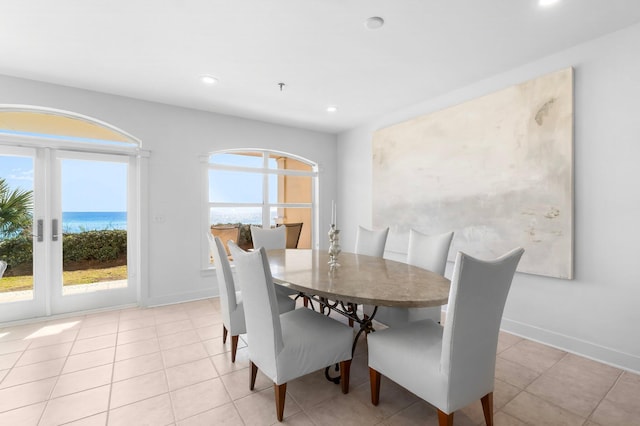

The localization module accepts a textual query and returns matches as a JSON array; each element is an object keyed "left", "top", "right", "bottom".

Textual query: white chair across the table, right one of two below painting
[{"left": 374, "top": 229, "right": 453, "bottom": 327}]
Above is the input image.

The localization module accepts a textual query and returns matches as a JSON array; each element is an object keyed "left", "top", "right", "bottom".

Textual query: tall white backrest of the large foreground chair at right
[{"left": 440, "top": 248, "right": 524, "bottom": 406}]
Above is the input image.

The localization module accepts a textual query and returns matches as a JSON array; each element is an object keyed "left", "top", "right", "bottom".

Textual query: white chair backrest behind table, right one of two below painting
[{"left": 407, "top": 229, "right": 453, "bottom": 275}]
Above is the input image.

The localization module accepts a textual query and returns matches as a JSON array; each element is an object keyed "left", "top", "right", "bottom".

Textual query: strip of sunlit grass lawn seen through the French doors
[{"left": 0, "top": 265, "right": 127, "bottom": 292}]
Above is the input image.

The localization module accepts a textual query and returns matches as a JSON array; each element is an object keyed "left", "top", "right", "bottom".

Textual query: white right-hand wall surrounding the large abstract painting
[{"left": 338, "top": 25, "right": 640, "bottom": 372}]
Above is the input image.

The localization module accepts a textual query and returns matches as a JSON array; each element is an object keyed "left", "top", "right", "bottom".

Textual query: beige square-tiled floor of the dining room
[{"left": 0, "top": 299, "right": 640, "bottom": 426}]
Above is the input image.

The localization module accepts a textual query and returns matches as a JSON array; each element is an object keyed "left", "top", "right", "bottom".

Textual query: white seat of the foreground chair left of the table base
[{"left": 274, "top": 309, "right": 353, "bottom": 384}]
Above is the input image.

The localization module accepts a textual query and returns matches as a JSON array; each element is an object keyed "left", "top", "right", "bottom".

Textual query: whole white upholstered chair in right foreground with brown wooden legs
[{"left": 367, "top": 248, "right": 524, "bottom": 426}]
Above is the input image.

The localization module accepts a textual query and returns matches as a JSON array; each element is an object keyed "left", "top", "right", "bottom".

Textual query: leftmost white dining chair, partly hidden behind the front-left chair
[{"left": 207, "top": 232, "right": 296, "bottom": 362}]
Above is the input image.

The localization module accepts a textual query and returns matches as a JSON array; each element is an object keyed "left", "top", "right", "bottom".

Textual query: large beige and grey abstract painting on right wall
[{"left": 373, "top": 68, "right": 573, "bottom": 279}]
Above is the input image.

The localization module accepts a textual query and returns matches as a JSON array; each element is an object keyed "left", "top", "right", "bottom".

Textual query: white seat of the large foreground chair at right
[{"left": 367, "top": 320, "right": 446, "bottom": 406}]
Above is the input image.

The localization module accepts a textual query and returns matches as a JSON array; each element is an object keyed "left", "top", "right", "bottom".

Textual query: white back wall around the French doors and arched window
[{"left": 0, "top": 76, "right": 336, "bottom": 305}]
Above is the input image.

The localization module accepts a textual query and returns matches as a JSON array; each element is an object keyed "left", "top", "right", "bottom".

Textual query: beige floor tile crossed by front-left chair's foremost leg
[{"left": 234, "top": 388, "right": 301, "bottom": 426}]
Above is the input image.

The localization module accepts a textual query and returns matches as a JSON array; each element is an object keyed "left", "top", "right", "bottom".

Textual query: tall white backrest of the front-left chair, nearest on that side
[{"left": 229, "top": 241, "right": 284, "bottom": 377}]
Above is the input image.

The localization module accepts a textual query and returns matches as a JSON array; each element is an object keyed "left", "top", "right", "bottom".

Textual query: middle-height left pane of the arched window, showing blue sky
[{"left": 209, "top": 170, "right": 263, "bottom": 203}]
